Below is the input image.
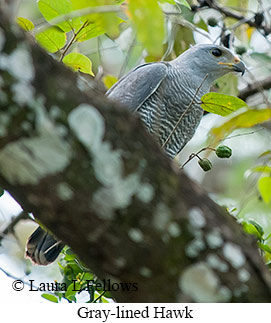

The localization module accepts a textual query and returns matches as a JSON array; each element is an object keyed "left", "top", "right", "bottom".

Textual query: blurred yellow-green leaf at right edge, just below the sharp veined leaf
[{"left": 209, "top": 109, "right": 271, "bottom": 146}]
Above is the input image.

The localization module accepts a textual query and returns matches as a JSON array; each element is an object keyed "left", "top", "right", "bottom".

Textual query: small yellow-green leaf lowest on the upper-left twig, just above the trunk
[{"left": 63, "top": 53, "right": 94, "bottom": 76}]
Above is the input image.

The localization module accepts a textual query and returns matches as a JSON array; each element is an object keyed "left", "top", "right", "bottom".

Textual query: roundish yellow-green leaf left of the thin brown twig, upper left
[{"left": 36, "top": 27, "right": 66, "bottom": 53}]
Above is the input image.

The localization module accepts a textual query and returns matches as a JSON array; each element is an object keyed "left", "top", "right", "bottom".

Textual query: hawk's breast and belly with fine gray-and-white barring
[{"left": 137, "top": 67, "right": 209, "bottom": 158}]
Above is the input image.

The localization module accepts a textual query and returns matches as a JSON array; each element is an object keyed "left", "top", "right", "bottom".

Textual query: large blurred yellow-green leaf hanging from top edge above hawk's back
[{"left": 129, "top": 0, "right": 165, "bottom": 57}]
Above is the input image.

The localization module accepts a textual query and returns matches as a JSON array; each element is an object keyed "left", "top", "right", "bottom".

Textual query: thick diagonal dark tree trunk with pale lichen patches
[{"left": 0, "top": 12, "right": 271, "bottom": 302}]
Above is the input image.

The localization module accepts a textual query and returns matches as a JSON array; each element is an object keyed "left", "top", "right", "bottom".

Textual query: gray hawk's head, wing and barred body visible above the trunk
[{"left": 107, "top": 45, "right": 245, "bottom": 158}]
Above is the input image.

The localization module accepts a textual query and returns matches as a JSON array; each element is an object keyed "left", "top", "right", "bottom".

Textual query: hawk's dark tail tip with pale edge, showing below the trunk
[{"left": 26, "top": 227, "right": 65, "bottom": 266}]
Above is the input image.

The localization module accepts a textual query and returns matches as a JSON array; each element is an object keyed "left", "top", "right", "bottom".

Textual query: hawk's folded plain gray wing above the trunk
[{"left": 106, "top": 62, "right": 167, "bottom": 112}]
